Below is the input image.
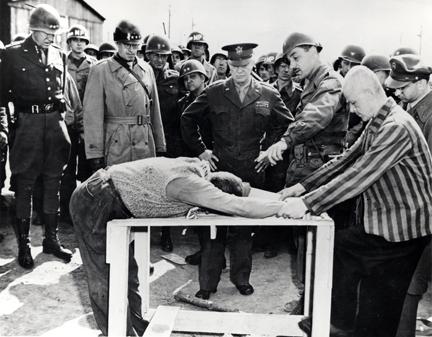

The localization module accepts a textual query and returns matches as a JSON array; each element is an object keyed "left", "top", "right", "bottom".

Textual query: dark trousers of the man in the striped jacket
[{"left": 331, "top": 225, "right": 430, "bottom": 337}]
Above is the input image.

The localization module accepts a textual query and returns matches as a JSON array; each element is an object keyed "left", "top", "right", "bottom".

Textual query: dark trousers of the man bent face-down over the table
[{"left": 70, "top": 169, "right": 147, "bottom": 336}]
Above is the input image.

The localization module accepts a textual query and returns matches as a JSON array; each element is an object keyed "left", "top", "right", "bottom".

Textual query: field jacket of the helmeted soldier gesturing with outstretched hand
[{"left": 283, "top": 64, "right": 348, "bottom": 154}]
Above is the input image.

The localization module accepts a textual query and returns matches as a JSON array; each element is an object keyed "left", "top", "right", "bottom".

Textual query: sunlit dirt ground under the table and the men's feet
[{"left": 0, "top": 189, "right": 432, "bottom": 337}]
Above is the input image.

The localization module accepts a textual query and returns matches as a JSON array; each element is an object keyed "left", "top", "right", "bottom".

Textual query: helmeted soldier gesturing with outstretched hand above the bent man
[{"left": 257, "top": 32, "right": 351, "bottom": 307}]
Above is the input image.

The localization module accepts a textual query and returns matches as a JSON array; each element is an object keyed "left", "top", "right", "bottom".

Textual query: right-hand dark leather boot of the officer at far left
[{"left": 42, "top": 214, "right": 72, "bottom": 263}]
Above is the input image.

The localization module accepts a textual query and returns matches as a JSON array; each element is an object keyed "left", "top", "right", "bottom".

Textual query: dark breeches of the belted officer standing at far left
[{"left": 10, "top": 111, "right": 70, "bottom": 219}]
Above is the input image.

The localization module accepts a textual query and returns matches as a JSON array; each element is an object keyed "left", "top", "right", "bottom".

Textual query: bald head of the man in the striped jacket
[{"left": 342, "top": 66, "right": 387, "bottom": 121}]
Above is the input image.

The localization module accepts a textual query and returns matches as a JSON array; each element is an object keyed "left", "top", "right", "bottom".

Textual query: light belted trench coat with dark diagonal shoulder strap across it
[{"left": 84, "top": 58, "right": 166, "bottom": 165}]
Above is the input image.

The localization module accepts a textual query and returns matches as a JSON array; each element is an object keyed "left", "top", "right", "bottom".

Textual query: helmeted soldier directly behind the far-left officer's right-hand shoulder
[{"left": 60, "top": 25, "right": 97, "bottom": 224}]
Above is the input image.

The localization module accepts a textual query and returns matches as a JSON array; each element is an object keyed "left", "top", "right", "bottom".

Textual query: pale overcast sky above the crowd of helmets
[{"left": 86, "top": 0, "right": 432, "bottom": 63}]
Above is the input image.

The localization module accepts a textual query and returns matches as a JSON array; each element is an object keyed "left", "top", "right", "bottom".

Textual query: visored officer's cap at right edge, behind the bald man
[{"left": 385, "top": 54, "right": 432, "bottom": 89}]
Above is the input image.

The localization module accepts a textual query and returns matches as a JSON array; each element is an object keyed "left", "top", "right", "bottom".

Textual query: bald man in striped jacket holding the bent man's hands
[{"left": 282, "top": 66, "right": 432, "bottom": 337}]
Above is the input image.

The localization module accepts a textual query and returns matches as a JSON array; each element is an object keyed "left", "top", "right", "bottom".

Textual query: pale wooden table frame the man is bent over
[{"left": 107, "top": 214, "right": 334, "bottom": 337}]
